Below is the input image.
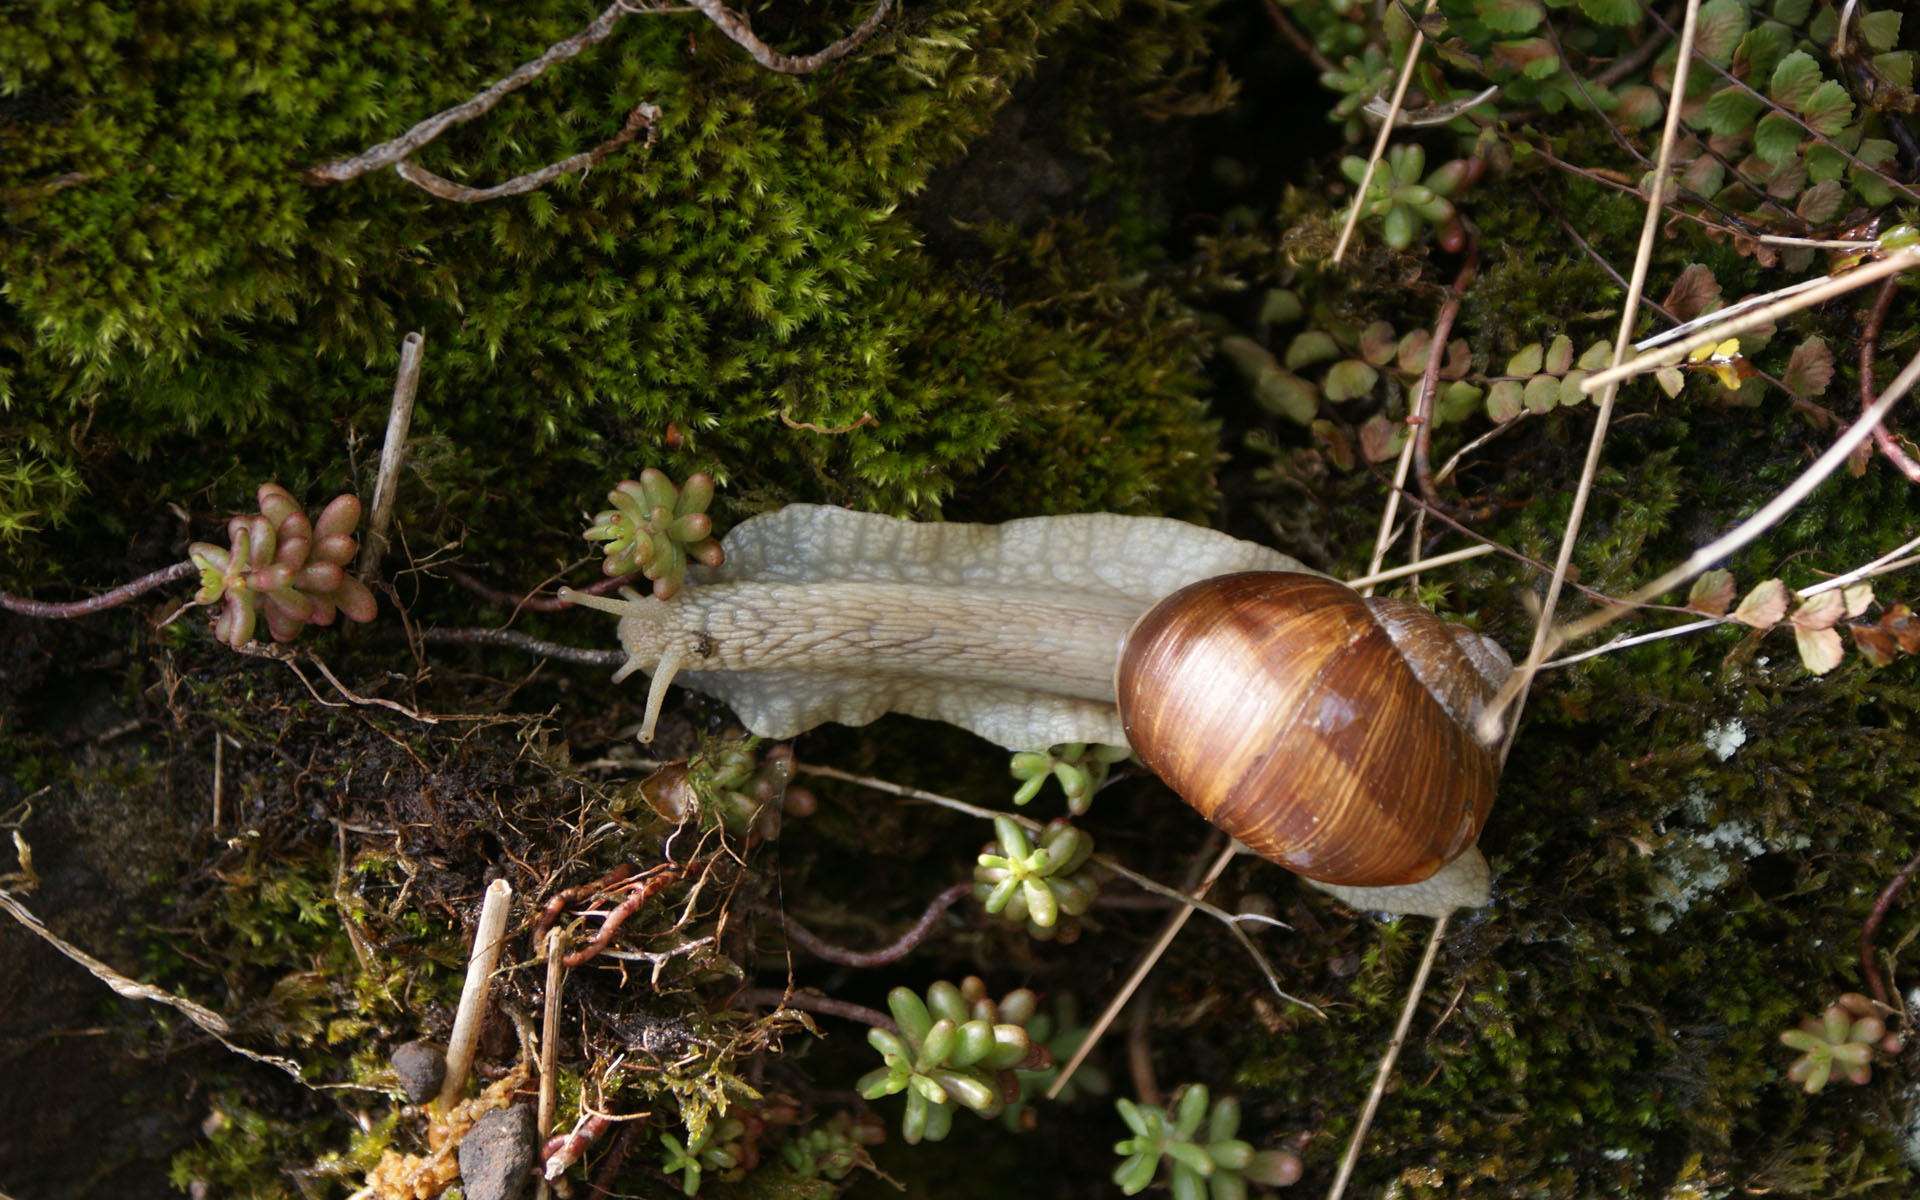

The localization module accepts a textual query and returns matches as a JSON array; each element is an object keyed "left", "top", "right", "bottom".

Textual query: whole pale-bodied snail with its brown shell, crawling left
[{"left": 561, "top": 505, "right": 1511, "bottom": 916}]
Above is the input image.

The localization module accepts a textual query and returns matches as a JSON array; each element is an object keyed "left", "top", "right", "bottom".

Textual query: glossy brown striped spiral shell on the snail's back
[{"left": 1116, "top": 572, "right": 1500, "bottom": 887}]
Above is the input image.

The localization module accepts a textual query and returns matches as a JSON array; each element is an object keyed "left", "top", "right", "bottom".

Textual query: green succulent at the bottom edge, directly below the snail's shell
[{"left": 1114, "top": 1083, "right": 1302, "bottom": 1200}]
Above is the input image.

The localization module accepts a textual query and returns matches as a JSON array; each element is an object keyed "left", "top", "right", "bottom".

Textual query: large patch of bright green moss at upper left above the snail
[{"left": 0, "top": 0, "right": 1212, "bottom": 583}]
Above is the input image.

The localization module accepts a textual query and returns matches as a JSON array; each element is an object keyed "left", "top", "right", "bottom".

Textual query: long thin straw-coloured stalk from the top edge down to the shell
[{"left": 1480, "top": 0, "right": 1699, "bottom": 762}]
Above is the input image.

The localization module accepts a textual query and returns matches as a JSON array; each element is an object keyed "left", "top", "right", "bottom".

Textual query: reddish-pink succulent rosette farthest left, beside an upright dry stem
[{"left": 186, "top": 484, "right": 376, "bottom": 649}]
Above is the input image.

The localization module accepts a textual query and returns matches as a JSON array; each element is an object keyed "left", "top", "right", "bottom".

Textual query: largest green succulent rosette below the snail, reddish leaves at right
[{"left": 856, "top": 975, "right": 1052, "bottom": 1146}]
